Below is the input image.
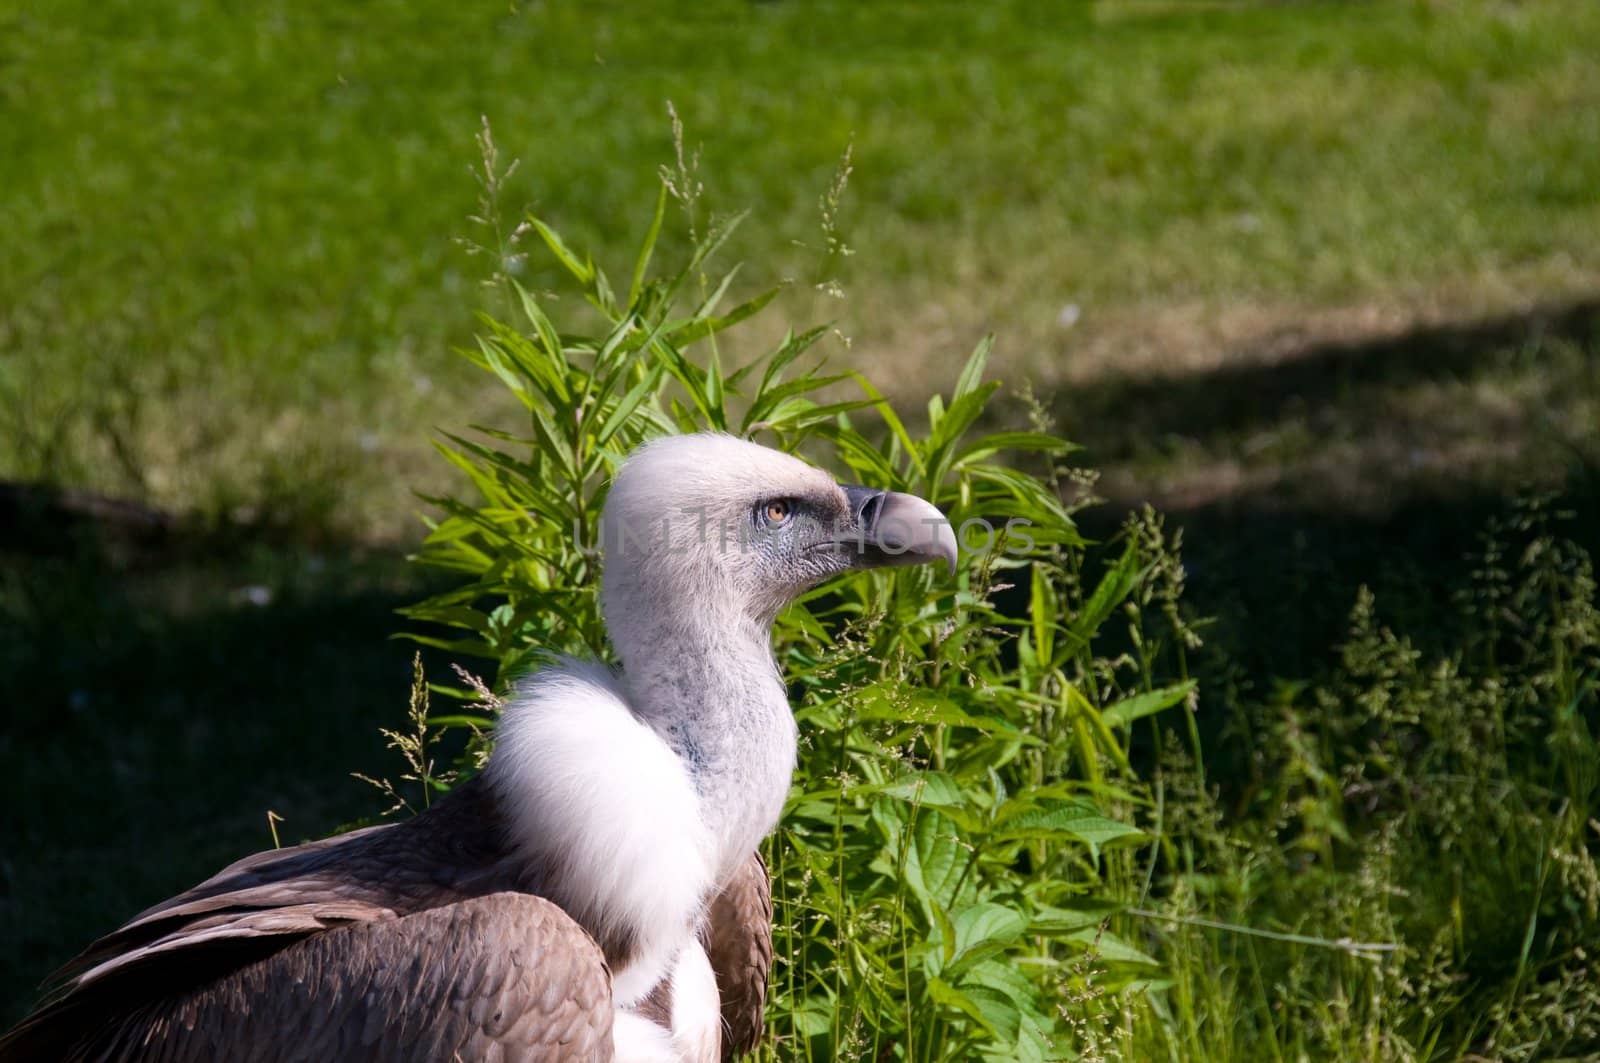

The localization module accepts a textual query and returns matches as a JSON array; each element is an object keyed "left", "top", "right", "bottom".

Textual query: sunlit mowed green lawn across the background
[{"left": 0, "top": 0, "right": 1600, "bottom": 538}]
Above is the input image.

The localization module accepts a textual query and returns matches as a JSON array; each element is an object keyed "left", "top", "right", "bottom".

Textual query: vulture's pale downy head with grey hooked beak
[{"left": 602, "top": 432, "right": 957, "bottom": 630}]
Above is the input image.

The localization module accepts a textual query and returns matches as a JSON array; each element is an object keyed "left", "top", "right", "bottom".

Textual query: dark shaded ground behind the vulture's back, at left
[{"left": 0, "top": 512, "right": 451, "bottom": 1025}]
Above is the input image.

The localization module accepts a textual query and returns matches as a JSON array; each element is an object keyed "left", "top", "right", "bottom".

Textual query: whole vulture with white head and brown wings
[{"left": 0, "top": 434, "right": 955, "bottom": 1063}]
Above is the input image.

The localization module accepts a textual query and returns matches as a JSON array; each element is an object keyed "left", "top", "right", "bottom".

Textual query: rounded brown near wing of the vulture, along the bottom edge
[{"left": 0, "top": 893, "right": 611, "bottom": 1063}]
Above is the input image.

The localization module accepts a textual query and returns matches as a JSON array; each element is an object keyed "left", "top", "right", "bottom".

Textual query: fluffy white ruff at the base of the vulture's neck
[{"left": 486, "top": 661, "right": 714, "bottom": 1007}]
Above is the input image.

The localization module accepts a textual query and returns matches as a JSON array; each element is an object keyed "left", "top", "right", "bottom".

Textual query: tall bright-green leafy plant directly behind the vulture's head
[{"left": 406, "top": 153, "right": 1192, "bottom": 1060}]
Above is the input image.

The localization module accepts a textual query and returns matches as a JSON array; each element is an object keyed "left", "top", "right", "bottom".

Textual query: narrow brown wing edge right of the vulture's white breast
[{"left": 701, "top": 853, "right": 773, "bottom": 1060}]
